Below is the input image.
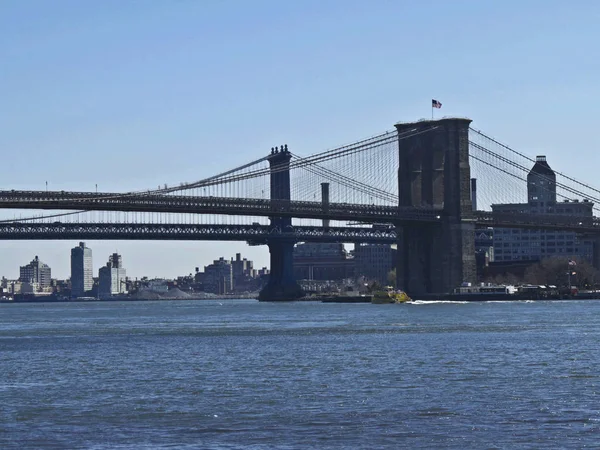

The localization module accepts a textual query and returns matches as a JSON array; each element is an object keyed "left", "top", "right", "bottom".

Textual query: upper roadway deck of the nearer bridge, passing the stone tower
[{"left": 0, "top": 190, "right": 600, "bottom": 234}]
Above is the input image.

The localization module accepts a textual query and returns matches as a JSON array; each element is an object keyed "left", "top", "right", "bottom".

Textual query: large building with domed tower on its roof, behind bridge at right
[{"left": 492, "top": 156, "right": 594, "bottom": 262}]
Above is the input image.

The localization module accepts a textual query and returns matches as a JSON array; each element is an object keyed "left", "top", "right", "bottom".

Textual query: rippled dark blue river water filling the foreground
[{"left": 0, "top": 300, "right": 600, "bottom": 449}]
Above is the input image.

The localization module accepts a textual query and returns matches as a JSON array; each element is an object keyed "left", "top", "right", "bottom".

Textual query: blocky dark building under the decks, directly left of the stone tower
[{"left": 354, "top": 244, "right": 397, "bottom": 285}]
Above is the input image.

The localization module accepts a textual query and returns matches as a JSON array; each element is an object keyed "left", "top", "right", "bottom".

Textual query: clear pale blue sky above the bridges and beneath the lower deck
[{"left": 0, "top": 0, "right": 600, "bottom": 278}]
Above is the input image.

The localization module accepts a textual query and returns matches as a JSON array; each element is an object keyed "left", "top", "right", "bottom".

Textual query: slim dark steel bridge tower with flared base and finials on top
[{"left": 258, "top": 145, "right": 304, "bottom": 301}]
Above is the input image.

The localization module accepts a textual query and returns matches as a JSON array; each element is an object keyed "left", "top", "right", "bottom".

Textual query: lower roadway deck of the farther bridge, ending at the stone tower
[{"left": 0, "top": 222, "right": 396, "bottom": 245}]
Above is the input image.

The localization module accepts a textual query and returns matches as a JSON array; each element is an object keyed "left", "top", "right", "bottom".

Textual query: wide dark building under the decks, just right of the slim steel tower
[{"left": 294, "top": 242, "right": 354, "bottom": 281}]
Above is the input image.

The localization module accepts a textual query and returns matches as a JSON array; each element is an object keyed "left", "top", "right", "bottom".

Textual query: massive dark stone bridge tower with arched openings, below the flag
[{"left": 396, "top": 118, "right": 476, "bottom": 298}]
